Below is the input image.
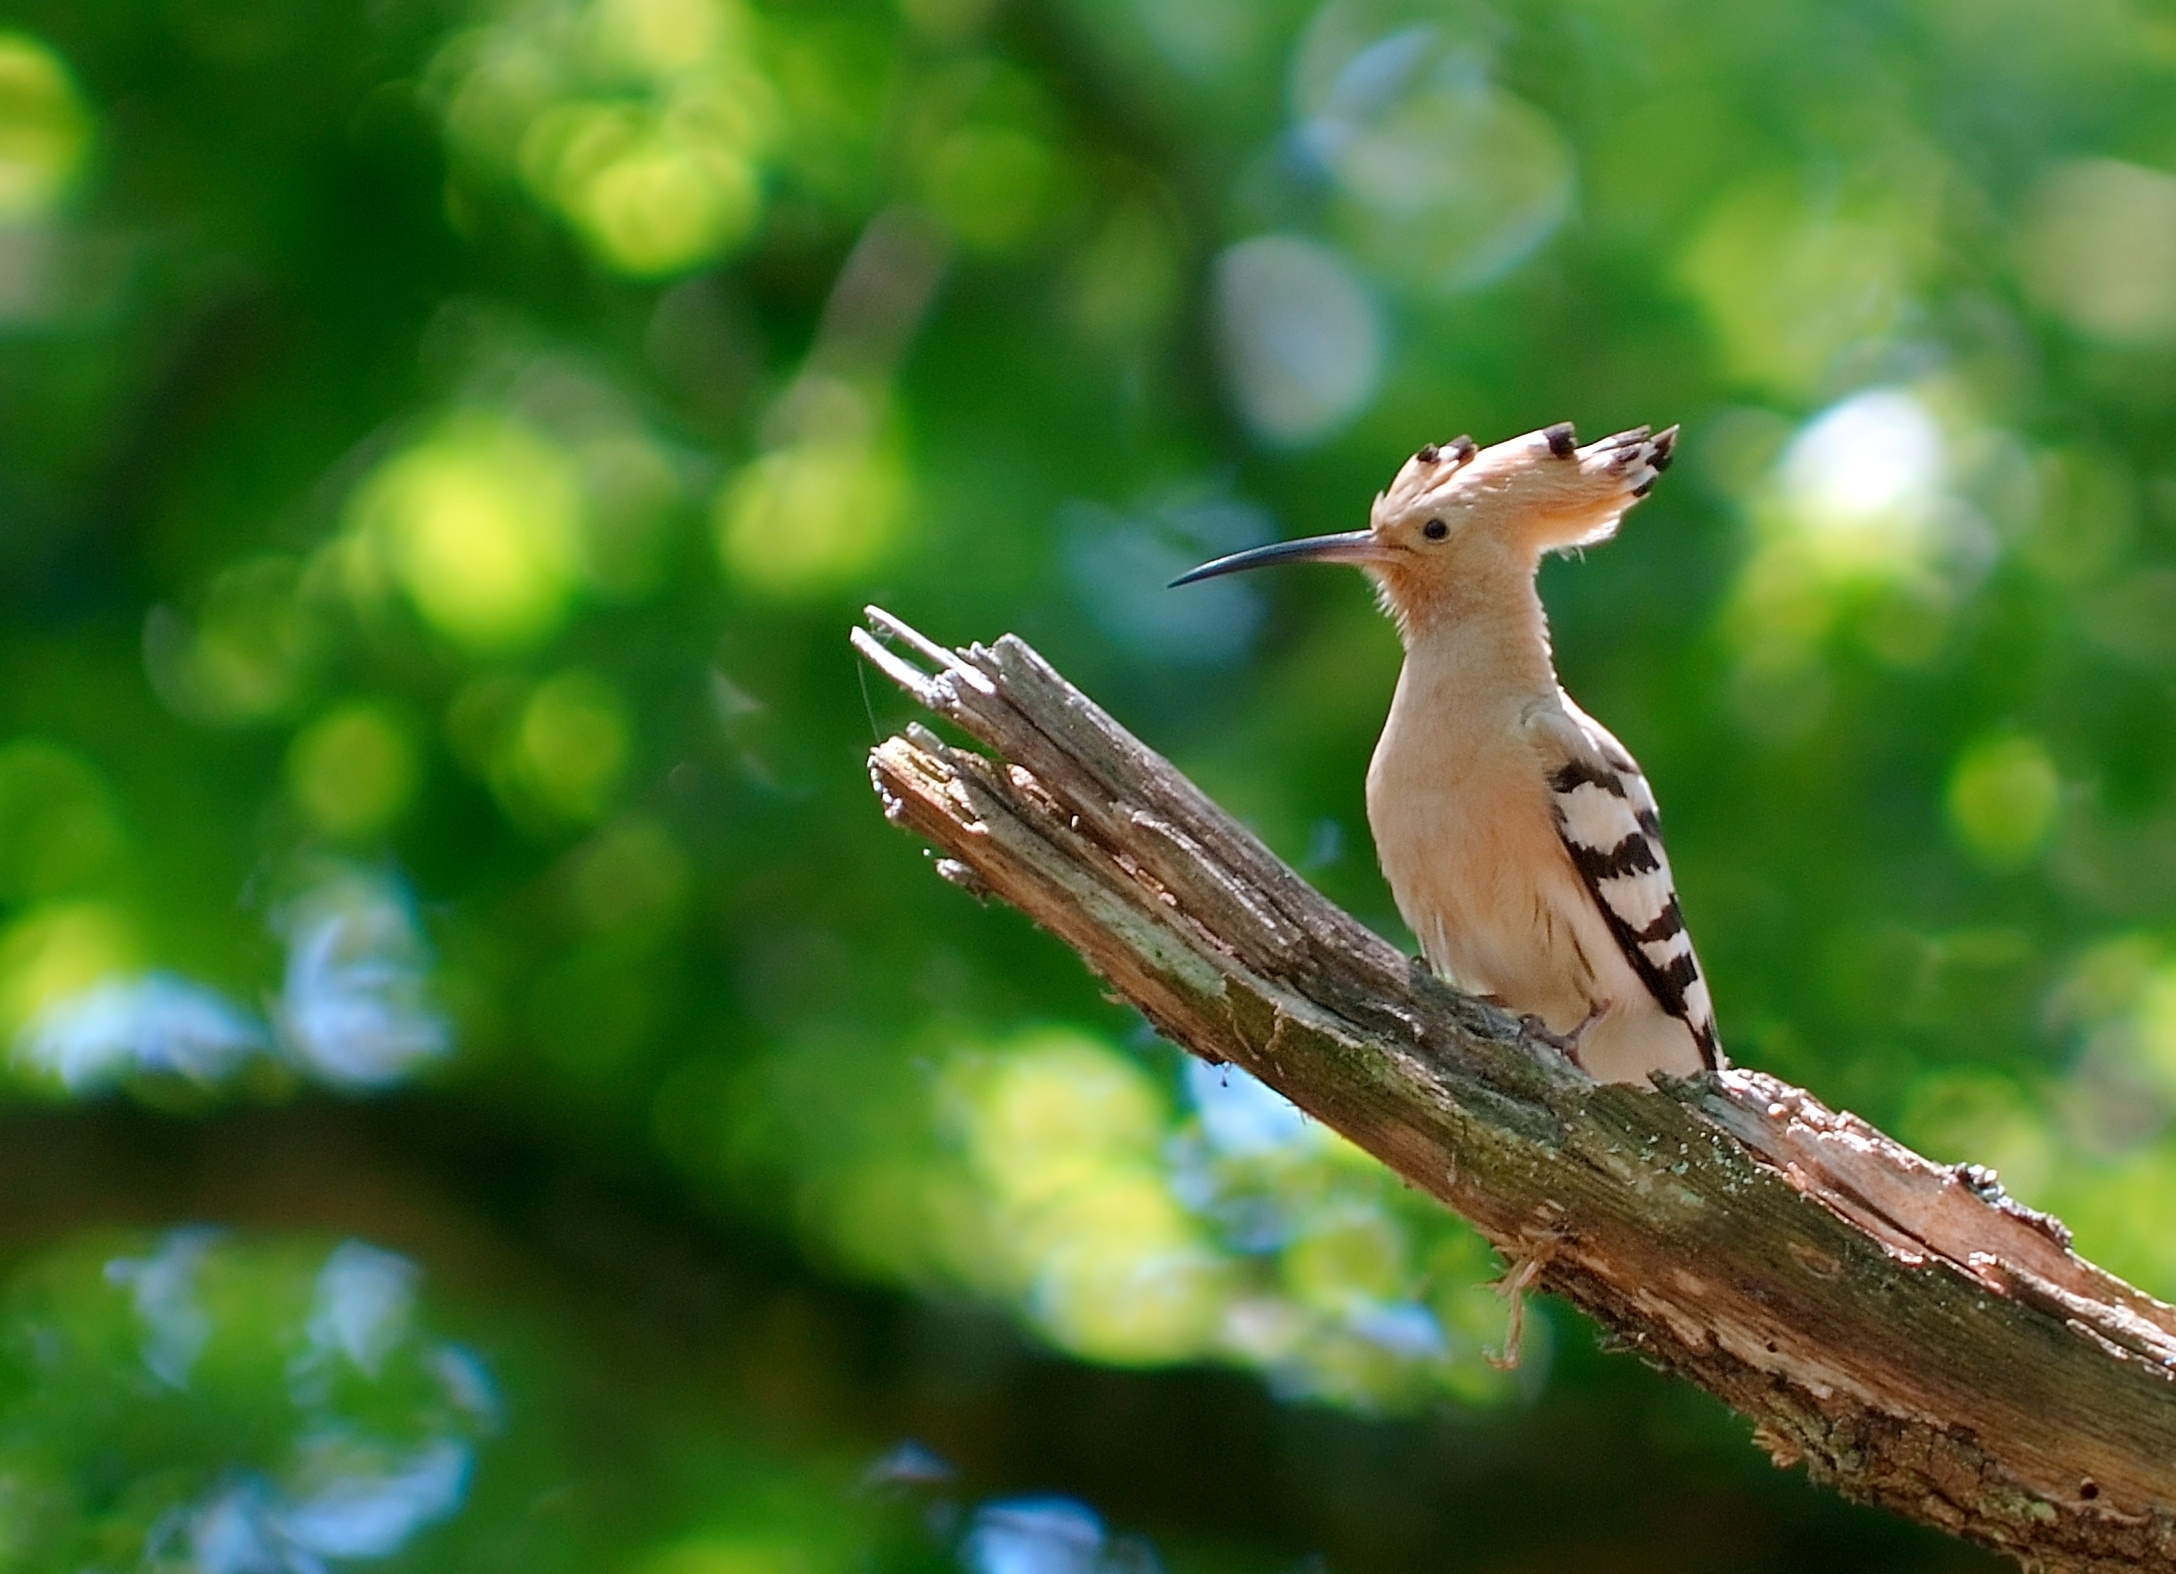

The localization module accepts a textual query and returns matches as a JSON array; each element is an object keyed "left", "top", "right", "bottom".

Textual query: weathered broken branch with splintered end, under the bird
[{"left": 853, "top": 607, "right": 2176, "bottom": 1572}]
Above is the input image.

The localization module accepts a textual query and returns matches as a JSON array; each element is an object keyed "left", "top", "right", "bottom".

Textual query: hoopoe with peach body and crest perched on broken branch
[{"left": 1171, "top": 420, "right": 1726, "bottom": 1082}]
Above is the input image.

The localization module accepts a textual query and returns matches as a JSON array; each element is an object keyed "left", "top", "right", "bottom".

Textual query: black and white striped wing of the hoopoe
[{"left": 1538, "top": 699, "right": 1721, "bottom": 1069}]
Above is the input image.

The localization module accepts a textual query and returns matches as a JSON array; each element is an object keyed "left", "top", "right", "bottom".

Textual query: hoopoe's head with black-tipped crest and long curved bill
[{"left": 1171, "top": 420, "right": 1678, "bottom": 627}]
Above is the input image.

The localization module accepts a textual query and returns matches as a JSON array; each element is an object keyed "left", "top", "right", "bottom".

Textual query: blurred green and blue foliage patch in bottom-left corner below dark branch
[{"left": 0, "top": 1226, "right": 494, "bottom": 1574}]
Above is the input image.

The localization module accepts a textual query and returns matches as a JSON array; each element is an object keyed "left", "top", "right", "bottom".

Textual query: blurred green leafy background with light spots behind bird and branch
[{"left": 0, "top": 0, "right": 2176, "bottom": 1574}]
